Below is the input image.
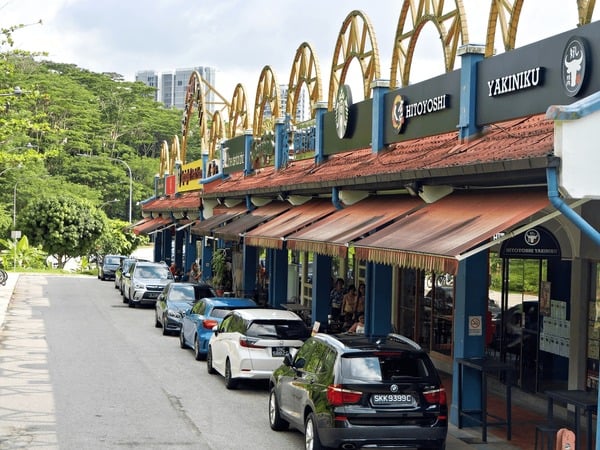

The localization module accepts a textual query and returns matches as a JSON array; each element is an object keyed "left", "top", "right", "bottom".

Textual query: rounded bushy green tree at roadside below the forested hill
[{"left": 18, "top": 197, "right": 105, "bottom": 269}]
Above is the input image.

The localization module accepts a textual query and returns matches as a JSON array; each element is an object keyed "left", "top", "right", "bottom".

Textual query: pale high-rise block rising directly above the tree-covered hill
[{"left": 135, "top": 66, "right": 217, "bottom": 113}]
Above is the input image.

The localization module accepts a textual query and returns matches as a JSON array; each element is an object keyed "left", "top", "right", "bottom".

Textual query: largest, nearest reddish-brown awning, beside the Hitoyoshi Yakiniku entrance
[{"left": 354, "top": 190, "right": 550, "bottom": 274}]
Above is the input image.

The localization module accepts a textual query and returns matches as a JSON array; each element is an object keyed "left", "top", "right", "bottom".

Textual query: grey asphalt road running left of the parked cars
[{"left": 0, "top": 275, "right": 303, "bottom": 450}]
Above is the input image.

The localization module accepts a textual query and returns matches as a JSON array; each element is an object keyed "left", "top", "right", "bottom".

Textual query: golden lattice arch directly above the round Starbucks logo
[{"left": 327, "top": 10, "right": 381, "bottom": 110}]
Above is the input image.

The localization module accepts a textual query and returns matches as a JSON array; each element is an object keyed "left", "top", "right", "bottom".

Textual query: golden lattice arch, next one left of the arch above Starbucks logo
[{"left": 285, "top": 42, "right": 323, "bottom": 123}]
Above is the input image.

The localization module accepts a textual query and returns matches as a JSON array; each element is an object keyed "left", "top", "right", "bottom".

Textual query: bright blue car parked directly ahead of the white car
[{"left": 179, "top": 297, "right": 259, "bottom": 361}]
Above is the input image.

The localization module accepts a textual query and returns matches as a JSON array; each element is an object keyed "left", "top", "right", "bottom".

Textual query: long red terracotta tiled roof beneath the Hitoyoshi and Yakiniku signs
[{"left": 204, "top": 114, "right": 554, "bottom": 197}]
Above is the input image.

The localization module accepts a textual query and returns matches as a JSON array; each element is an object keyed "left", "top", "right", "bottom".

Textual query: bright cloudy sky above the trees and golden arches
[{"left": 0, "top": 0, "right": 600, "bottom": 103}]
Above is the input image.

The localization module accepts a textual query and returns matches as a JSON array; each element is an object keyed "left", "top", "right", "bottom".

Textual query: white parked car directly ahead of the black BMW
[{"left": 206, "top": 308, "right": 310, "bottom": 389}]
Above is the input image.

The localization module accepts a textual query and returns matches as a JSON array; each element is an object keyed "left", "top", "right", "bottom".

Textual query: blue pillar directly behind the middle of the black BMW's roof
[{"left": 365, "top": 263, "right": 393, "bottom": 335}]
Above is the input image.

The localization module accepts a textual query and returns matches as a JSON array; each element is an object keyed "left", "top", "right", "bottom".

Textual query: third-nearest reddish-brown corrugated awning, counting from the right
[{"left": 244, "top": 199, "right": 335, "bottom": 250}]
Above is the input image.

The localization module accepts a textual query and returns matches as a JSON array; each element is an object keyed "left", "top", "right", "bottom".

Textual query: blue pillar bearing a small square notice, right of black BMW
[{"left": 450, "top": 252, "right": 489, "bottom": 426}]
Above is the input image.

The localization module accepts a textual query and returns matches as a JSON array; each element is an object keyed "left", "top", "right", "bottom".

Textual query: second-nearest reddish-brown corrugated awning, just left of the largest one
[{"left": 286, "top": 195, "right": 424, "bottom": 258}]
